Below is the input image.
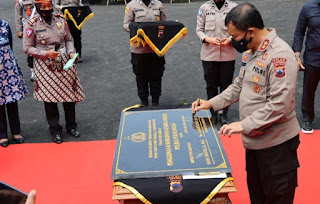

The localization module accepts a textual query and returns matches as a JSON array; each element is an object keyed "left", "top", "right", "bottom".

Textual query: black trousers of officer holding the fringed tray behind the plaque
[{"left": 131, "top": 53, "right": 165, "bottom": 99}]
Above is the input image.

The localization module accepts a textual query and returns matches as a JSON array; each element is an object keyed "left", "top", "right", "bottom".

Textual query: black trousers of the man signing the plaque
[{"left": 246, "top": 135, "right": 300, "bottom": 204}]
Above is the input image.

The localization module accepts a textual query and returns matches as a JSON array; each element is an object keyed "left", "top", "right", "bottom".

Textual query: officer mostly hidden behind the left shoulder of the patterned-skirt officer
[{"left": 15, "top": 0, "right": 34, "bottom": 81}]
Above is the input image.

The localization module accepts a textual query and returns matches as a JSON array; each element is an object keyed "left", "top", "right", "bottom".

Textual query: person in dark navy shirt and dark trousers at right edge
[{"left": 292, "top": 0, "right": 320, "bottom": 134}]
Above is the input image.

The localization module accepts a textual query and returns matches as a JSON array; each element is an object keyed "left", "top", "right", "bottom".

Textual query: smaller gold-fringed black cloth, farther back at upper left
[{"left": 62, "top": 6, "right": 94, "bottom": 30}]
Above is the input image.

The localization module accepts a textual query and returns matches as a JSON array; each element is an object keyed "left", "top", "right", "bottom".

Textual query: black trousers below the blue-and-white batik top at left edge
[{"left": 0, "top": 102, "right": 21, "bottom": 139}]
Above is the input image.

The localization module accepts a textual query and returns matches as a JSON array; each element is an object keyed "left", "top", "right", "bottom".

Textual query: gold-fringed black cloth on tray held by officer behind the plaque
[{"left": 129, "top": 21, "right": 188, "bottom": 56}]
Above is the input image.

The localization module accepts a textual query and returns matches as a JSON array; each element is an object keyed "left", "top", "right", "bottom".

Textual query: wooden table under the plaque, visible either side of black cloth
[{"left": 112, "top": 181, "right": 237, "bottom": 204}]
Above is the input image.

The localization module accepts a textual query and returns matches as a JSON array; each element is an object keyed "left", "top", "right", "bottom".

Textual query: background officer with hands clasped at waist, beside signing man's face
[{"left": 196, "top": 0, "right": 237, "bottom": 125}]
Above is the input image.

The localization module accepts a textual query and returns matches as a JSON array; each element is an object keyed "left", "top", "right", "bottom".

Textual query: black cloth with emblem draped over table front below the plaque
[{"left": 115, "top": 174, "right": 231, "bottom": 204}]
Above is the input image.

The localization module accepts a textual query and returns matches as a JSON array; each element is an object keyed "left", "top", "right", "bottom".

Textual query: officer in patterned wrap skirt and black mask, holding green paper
[{"left": 23, "top": 0, "right": 84, "bottom": 143}]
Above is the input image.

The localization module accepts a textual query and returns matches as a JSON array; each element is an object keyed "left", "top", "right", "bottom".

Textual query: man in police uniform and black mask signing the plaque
[{"left": 192, "top": 3, "right": 300, "bottom": 204}]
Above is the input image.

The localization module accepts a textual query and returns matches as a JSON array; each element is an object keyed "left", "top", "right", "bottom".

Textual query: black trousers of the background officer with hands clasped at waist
[{"left": 202, "top": 60, "right": 235, "bottom": 114}]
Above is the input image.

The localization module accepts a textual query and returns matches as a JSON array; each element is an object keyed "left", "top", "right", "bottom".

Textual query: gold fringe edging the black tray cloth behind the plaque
[{"left": 130, "top": 28, "right": 188, "bottom": 57}]
